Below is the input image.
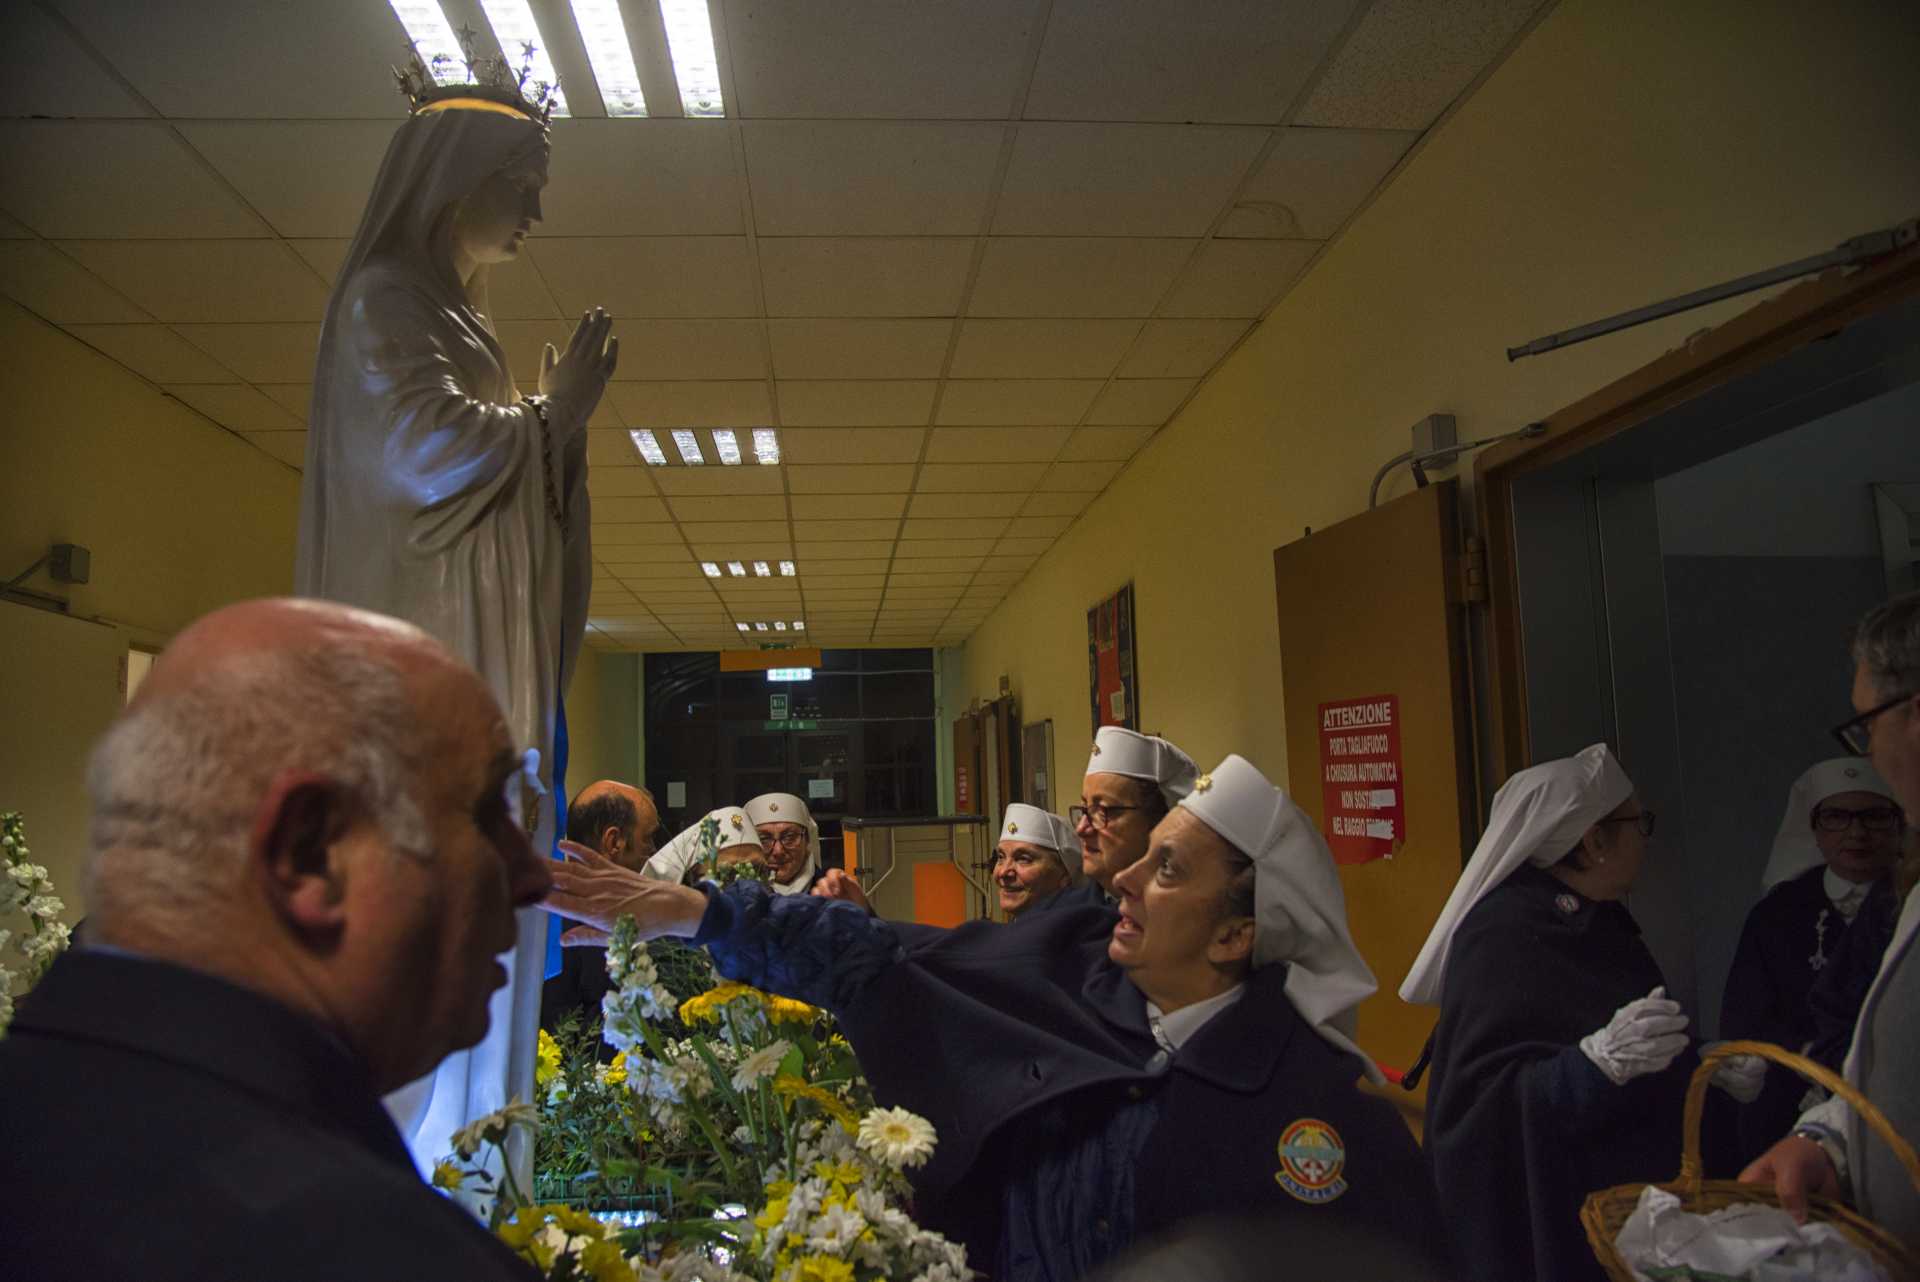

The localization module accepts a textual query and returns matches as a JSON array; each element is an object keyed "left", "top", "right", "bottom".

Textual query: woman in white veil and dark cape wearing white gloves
[{"left": 1400, "top": 745, "right": 1759, "bottom": 1282}]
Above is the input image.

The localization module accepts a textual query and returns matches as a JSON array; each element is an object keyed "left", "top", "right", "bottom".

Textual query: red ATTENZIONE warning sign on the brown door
[{"left": 1319, "top": 695, "right": 1407, "bottom": 864}]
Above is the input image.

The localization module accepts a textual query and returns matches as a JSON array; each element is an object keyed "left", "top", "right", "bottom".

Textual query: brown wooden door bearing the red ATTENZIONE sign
[{"left": 1273, "top": 480, "right": 1478, "bottom": 1097}]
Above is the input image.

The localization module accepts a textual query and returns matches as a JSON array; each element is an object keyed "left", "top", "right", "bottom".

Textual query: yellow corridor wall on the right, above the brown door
[{"left": 956, "top": 0, "right": 1920, "bottom": 790}]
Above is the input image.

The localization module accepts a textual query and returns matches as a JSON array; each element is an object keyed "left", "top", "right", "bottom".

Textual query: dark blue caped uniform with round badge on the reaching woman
[{"left": 695, "top": 883, "right": 1438, "bottom": 1282}]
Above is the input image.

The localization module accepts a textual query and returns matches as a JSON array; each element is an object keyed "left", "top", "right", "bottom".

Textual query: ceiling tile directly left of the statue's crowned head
[{"left": 180, "top": 119, "right": 394, "bottom": 236}]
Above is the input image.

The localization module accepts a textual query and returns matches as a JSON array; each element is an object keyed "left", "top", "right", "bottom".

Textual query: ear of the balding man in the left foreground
[{"left": 248, "top": 772, "right": 357, "bottom": 935}]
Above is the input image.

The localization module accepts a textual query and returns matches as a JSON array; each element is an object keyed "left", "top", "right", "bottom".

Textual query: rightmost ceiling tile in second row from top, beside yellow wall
[{"left": 1217, "top": 129, "right": 1419, "bottom": 240}]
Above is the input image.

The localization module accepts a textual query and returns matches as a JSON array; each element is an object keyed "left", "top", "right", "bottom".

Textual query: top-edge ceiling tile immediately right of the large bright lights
[{"left": 726, "top": 0, "right": 1039, "bottom": 121}]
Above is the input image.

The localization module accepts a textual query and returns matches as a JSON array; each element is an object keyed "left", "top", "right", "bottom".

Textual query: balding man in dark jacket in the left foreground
[{"left": 0, "top": 601, "right": 551, "bottom": 1282}]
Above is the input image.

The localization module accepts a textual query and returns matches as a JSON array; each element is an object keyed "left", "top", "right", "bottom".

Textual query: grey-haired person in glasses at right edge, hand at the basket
[{"left": 1740, "top": 593, "right": 1920, "bottom": 1244}]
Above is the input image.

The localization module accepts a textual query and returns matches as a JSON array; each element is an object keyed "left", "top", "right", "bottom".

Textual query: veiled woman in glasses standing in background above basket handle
[{"left": 1720, "top": 756, "right": 1907, "bottom": 1157}]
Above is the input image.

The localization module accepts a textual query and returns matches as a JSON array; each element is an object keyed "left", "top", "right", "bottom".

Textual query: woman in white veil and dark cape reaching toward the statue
[{"left": 553, "top": 756, "right": 1438, "bottom": 1282}]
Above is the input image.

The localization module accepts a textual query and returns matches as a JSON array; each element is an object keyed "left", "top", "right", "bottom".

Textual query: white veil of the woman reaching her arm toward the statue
[{"left": 1179, "top": 756, "right": 1384, "bottom": 1082}]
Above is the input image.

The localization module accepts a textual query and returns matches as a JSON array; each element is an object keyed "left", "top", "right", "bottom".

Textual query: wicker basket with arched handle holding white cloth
[{"left": 1580, "top": 1042, "right": 1920, "bottom": 1282}]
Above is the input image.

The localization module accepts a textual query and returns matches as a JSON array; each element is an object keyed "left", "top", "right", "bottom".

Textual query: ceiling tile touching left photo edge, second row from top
[{"left": 0, "top": 121, "right": 269, "bottom": 240}]
